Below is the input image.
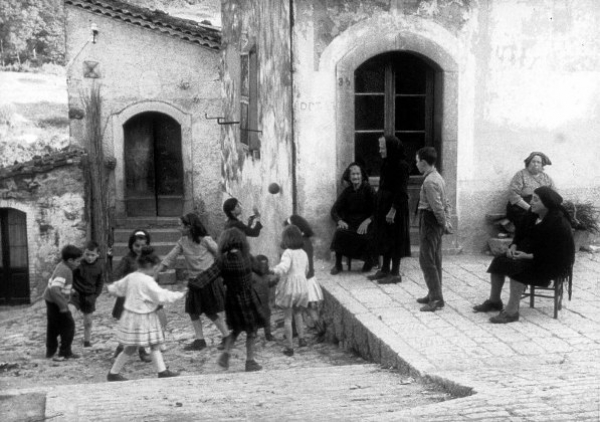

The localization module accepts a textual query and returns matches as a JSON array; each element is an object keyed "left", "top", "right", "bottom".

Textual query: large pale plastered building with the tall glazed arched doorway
[{"left": 221, "top": 0, "right": 600, "bottom": 257}]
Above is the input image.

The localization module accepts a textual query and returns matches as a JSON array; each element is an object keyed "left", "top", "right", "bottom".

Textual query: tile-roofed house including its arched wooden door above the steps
[{"left": 64, "top": 0, "right": 223, "bottom": 244}]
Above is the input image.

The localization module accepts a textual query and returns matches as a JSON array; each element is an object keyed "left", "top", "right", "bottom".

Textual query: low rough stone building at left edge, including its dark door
[{"left": 0, "top": 149, "right": 88, "bottom": 304}]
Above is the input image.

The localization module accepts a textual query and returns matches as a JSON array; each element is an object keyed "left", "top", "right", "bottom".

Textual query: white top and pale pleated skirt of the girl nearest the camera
[{"left": 108, "top": 271, "right": 184, "bottom": 347}]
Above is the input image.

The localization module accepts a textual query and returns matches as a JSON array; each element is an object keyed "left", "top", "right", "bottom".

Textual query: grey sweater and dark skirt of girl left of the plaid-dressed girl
[{"left": 162, "top": 236, "right": 225, "bottom": 315}]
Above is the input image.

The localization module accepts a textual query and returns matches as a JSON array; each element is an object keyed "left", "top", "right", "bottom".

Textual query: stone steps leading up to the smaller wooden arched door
[{"left": 113, "top": 217, "right": 185, "bottom": 284}]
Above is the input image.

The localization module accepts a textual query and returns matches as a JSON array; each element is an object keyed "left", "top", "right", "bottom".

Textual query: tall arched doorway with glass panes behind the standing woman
[{"left": 354, "top": 51, "right": 442, "bottom": 236}]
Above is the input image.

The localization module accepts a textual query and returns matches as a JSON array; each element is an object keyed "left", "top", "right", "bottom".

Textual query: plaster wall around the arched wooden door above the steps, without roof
[{"left": 66, "top": 6, "right": 222, "bottom": 231}]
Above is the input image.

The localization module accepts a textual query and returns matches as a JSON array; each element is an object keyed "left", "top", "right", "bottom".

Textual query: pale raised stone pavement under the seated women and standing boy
[{"left": 321, "top": 253, "right": 600, "bottom": 421}]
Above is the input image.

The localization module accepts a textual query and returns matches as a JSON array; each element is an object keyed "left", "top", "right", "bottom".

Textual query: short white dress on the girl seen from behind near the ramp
[{"left": 273, "top": 249, "right": 308, "bottom": 308}]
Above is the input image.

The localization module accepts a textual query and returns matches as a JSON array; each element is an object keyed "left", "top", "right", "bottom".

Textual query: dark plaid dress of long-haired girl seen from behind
[{"left": 188, "top": 251, "right": 266, "bottom": 333}]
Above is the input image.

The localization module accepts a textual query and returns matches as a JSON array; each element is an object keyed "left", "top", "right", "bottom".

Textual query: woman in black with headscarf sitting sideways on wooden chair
[{"left": 473, "top": 186, "right": 575, "bottom": 324}]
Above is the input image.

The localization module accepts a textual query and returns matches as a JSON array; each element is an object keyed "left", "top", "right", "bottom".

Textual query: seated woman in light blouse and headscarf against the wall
[{"left": 506, "top": 151, "right": 555, "bottom": 231}]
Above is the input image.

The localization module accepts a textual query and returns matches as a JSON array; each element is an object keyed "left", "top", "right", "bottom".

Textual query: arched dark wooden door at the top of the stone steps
[{"left": 123, "top": 112, "right": 184, "bottom": 217}]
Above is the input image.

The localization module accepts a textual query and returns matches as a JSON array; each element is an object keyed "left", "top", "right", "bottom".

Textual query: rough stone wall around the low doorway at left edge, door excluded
[{"left": 0, "top": 164, "right": 86, "bottom": 302}]
